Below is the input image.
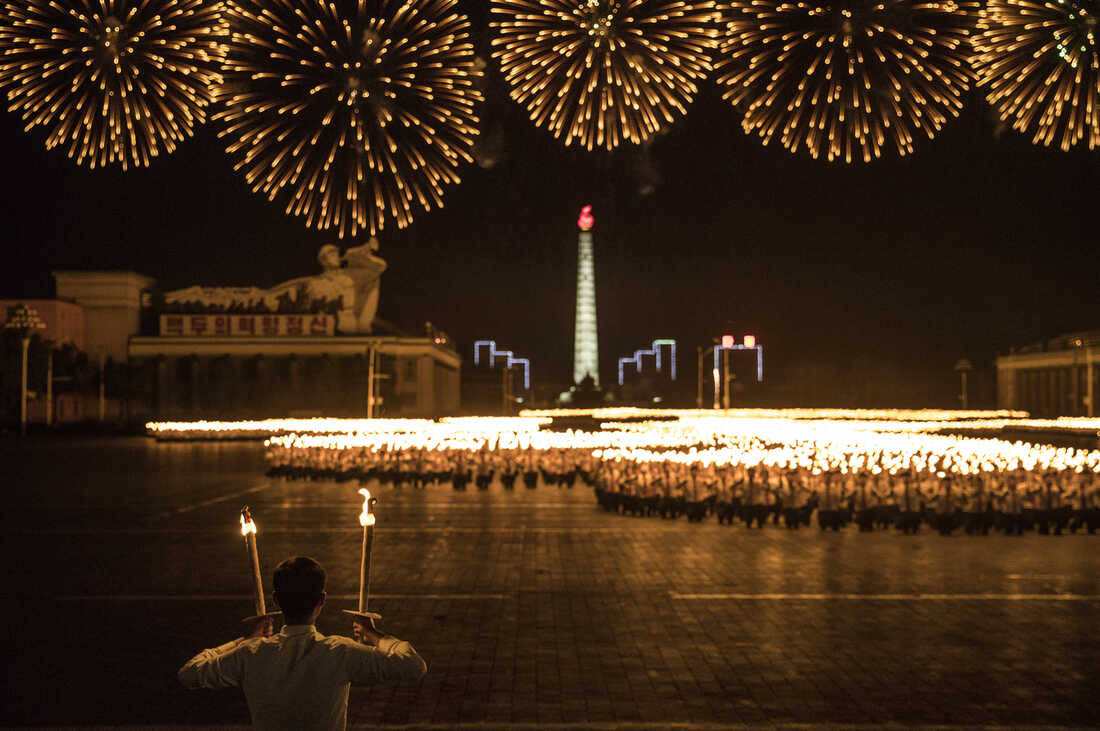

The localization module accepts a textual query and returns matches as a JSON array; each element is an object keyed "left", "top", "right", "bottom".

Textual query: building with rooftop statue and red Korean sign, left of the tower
[{"left": 128, "top": 244, "right": 461, "bottom": 419}]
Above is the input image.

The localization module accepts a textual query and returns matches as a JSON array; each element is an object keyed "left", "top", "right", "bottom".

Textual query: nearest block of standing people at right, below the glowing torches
[{"left": 595, "top": 463, "right": 1100, "bottom": 535}]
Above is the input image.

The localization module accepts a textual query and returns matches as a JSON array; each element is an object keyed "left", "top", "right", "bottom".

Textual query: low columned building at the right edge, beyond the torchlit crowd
[{"left": 997, "top": 330, "right": 1100, "bottom": 418}]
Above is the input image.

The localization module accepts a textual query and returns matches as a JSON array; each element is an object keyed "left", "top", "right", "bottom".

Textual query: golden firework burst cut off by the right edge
[{"left": 974, "top": 0, "right": 1100, "bottom": 149}]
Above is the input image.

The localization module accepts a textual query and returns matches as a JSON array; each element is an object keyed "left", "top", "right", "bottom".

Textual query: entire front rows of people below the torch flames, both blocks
[{"left": 261, "top": 445, "right": 1100, "bottom": 535}]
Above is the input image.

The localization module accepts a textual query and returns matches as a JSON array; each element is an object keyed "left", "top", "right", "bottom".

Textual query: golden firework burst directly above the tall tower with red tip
[{"left": 491, "top": 0, "right": 718, "bottom": 149}]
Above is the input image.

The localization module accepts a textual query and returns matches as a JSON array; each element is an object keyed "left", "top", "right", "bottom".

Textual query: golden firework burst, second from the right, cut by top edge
[{"left": 718, "top": 0, "right": 977, "bottom": 163}]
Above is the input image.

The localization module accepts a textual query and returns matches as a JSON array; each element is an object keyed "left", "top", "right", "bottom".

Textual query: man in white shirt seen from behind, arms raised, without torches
[{"left": 179, "top": 556, "right": 428, "bottom": 731}]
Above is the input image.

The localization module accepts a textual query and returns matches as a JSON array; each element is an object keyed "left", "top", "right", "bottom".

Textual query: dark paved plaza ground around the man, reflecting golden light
[{"left": 0, "top": 439, "right": 1100, "bottom": 729}]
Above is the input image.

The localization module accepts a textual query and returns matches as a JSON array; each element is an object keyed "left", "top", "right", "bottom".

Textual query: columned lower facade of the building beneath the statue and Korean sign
[{"left": 130, "top": 335, "right": 461, "bottom": 420}]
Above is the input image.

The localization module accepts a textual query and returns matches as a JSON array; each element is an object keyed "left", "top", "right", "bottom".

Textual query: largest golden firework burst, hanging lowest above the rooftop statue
[{"left": 216, "top": 0, "right": 481, "bottom": 237}]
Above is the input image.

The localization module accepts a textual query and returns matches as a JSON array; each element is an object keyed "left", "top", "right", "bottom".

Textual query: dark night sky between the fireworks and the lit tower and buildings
[{"left": 0, "top": 2, "right": 1100, "bottom": 381}]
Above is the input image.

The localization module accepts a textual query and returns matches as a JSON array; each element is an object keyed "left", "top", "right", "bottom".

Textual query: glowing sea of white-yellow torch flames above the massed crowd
[{"left": 147, "top": 408, "right": 1100, "bottom": 478}]
